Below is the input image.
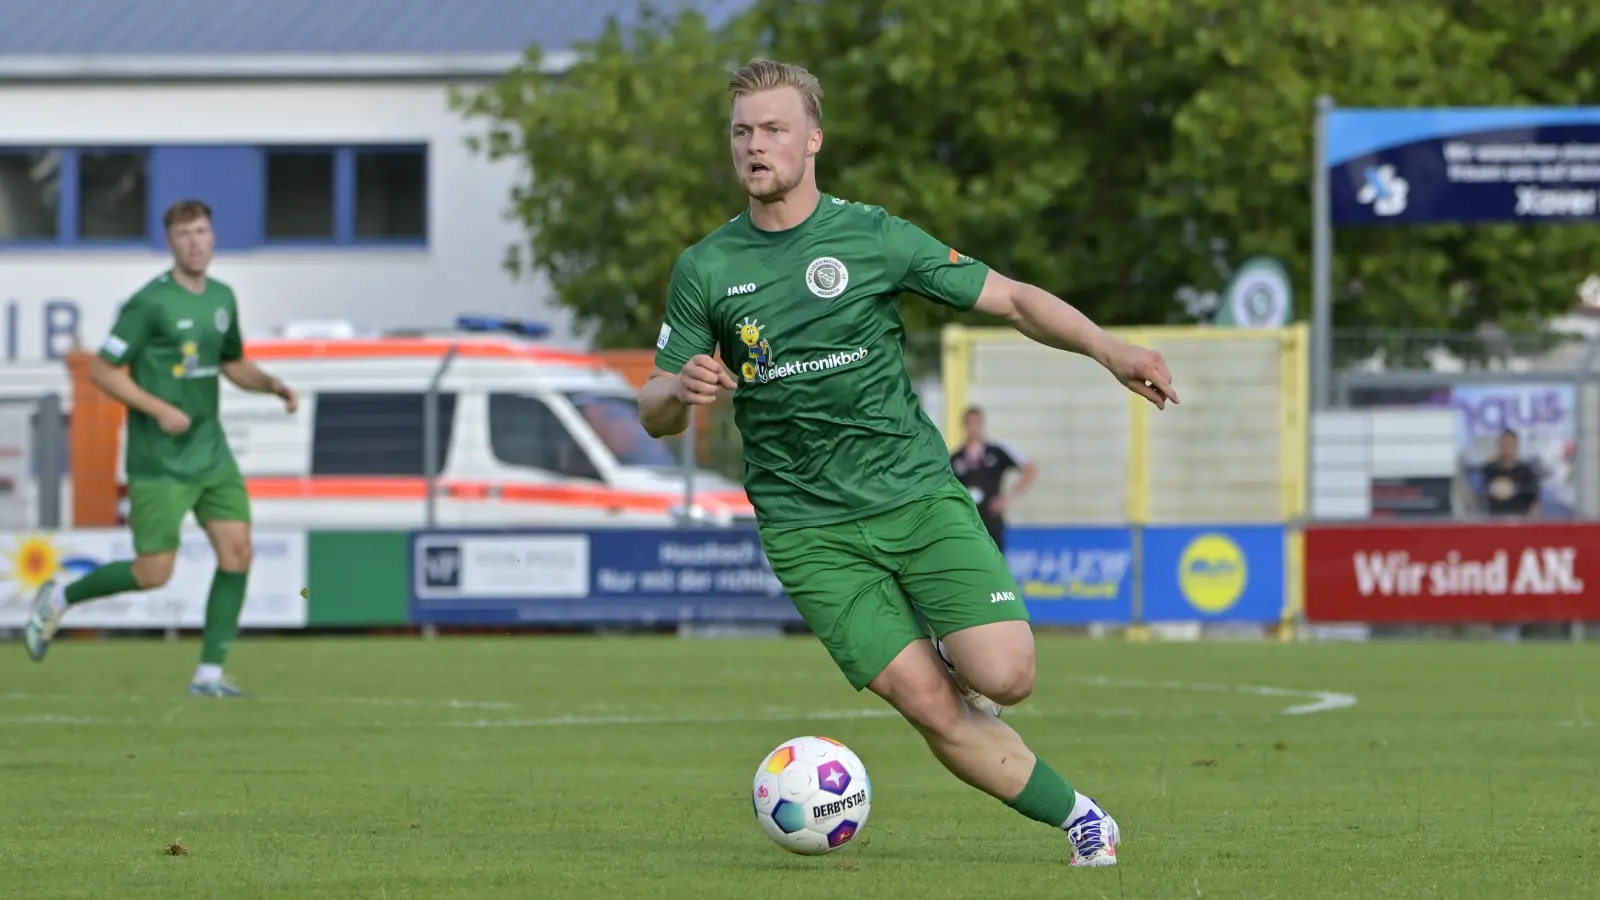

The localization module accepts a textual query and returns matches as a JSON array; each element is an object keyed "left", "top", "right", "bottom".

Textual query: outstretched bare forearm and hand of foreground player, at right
[{"left": 974, "top": 271, "right": 1178, "bottom": 410}]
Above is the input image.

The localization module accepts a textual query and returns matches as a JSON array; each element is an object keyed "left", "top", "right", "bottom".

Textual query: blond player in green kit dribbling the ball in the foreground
[{"left": 640, "top": 61, "right": 1178, "bottom": 866}]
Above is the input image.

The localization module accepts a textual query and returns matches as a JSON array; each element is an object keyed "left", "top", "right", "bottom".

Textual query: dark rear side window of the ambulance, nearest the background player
[{"left": 310, "top": 392, "right": 456, "bottom": 477}]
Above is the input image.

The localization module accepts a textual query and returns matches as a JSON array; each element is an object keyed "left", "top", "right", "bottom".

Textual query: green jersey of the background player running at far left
[{"left": 99, "top": 272, "right": 245, "bottom": 480}]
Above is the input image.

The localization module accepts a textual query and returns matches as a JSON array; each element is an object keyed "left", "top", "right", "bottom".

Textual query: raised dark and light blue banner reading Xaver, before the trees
[{"left": 1323, "top": 107, "right": 1600, "bottom": 224}]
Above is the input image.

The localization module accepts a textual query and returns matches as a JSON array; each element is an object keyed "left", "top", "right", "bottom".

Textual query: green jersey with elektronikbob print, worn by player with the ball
[{"left": 656, "top": 194, "right": 989, "bottom": 528}]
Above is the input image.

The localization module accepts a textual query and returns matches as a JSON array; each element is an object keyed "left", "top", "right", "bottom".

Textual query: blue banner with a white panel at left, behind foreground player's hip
[{"left": 411, "top": 528, "right": 800, "bottom": 625}]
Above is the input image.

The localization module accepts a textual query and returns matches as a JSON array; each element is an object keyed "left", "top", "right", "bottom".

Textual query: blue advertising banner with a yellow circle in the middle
[{"left": 1144, "top": 525, "right": 1285, "bottom": 621}]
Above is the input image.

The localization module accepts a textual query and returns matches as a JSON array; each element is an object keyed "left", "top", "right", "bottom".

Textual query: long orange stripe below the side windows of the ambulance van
[{"left": 245, "top": 477, "right": 750, "bottom": 514}]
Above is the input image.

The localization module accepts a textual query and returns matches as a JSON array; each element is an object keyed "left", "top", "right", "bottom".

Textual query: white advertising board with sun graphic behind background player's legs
[{"left": 0, "top": 528, "right": 306, "bottom": 629}]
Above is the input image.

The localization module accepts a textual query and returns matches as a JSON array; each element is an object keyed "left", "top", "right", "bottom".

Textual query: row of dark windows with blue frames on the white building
[{"left": 0, "top": 144, "right": 429, "bottom": 251}]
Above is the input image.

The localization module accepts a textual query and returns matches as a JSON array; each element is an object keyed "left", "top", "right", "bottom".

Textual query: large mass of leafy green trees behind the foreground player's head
[{"left": 461, "top": 0, "right": 1600, "bottom": 346}]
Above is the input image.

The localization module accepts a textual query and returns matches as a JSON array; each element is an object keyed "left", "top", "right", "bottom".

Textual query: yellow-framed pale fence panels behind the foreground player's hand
[{"left": 944, "top": 325, "right": 1307, "bottom": 525}]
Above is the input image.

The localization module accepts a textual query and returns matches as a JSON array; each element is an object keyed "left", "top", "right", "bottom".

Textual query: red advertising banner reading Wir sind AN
[{"left": 1306, "top": 522, "right": 1600, "bottom": 623}]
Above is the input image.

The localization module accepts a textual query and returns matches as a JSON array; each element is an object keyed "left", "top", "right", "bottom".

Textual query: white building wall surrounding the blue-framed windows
[{"left": 0, "top": 82, "right": 576, "bottom": 362}]
